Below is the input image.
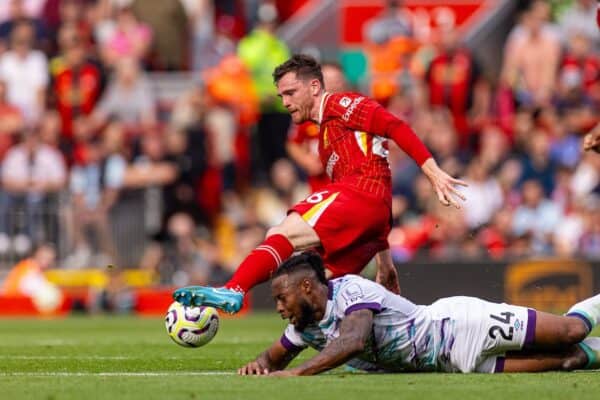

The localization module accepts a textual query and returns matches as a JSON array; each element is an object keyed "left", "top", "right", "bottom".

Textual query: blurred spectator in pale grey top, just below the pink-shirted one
[{"left": 91, "top": 58, "right": 157, "bottom": 134}]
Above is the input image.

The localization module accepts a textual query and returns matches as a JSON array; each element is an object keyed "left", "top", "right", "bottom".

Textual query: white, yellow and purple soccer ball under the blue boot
[{"left": 165, "top": 302, "right": 219, "bottom": 347}]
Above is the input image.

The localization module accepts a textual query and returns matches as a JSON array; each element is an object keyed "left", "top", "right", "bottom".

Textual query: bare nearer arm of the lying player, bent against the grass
[{"left": 270, "top": 309, "right": 373, "bottom": 376}]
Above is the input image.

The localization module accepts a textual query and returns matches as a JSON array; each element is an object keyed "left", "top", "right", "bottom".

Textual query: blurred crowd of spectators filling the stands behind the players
[{"left": 0, "top": 0, "right": 600, "bottom": 285}]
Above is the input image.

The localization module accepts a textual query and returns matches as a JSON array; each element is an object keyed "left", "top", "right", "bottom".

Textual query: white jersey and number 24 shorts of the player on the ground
[{"left": 281, "top": 275, "right": 535, "bottom": 372}]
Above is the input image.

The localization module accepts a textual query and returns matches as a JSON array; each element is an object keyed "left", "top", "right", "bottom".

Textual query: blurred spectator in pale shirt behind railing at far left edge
[{"left": 0, "top": 130, "right": 67, "bottom": 254}]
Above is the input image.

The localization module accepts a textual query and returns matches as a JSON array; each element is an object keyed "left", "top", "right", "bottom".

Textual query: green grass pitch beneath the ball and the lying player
[{"left": 0, "top": 314, "right": 600, "bottom": 400}]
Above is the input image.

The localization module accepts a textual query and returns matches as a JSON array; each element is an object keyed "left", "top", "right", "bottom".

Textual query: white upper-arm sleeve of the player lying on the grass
[{"left": 335, "top": 279, "right": 385, "bottom": 315}]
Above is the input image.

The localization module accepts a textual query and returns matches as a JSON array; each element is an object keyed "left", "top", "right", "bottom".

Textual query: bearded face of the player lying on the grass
[{"left": 271, "top": 275, "right": 315, "bottom": 331}]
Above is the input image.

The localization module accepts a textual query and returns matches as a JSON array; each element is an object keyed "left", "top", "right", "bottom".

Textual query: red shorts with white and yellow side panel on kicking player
[{"left": 288, "top": 183, "right": 391, "bottom": 277}]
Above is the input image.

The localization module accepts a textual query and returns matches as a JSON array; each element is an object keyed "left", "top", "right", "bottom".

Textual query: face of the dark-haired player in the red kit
[{"left": 277, "top": 72, "right": 320, "bottom": 124}]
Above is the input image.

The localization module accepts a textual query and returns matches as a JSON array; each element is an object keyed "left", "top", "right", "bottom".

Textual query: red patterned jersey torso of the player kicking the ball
[{"left": 319, "top": 93, "right": 392, "bottom": 201}]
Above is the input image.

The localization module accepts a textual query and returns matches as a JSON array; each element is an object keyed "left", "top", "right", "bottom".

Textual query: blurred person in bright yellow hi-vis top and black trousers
[{"left": 238, "top": 2, "right": 290, "bottom": 178}]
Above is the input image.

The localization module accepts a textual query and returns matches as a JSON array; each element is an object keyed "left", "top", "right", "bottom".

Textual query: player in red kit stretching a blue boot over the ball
[{"left": 173, "top": 55, "right": 466, "bottom": 313}]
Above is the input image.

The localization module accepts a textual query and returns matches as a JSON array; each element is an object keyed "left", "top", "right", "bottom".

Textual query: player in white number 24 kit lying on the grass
[{"left": 238, "top": 253, "right": 600, "bottom": 376}]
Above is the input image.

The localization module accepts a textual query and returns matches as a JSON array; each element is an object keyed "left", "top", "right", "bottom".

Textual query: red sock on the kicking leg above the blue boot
[{"left": 225, "top": 234, "right": 294, "bottom": 293}]
